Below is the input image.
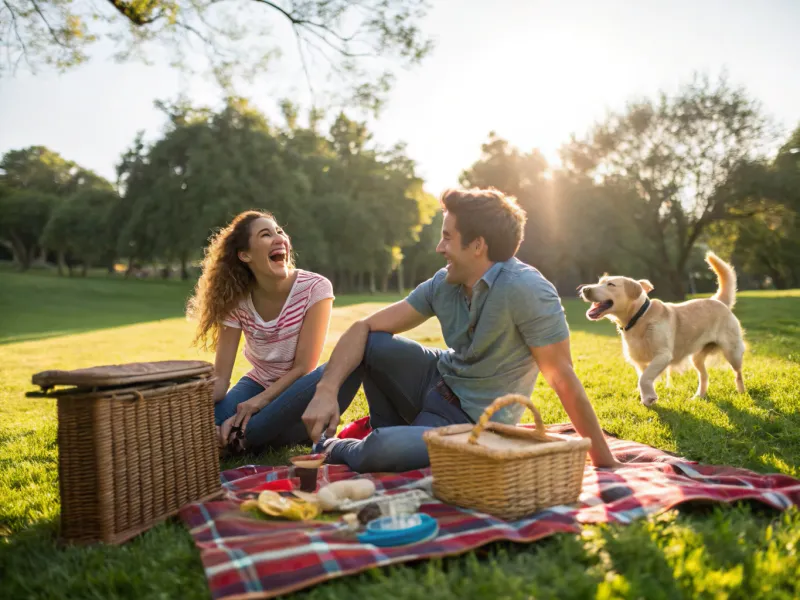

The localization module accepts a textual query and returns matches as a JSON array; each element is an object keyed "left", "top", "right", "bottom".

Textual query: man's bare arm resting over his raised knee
[{"left": 303, "top": 300, "right": 429, "bottom": 443}]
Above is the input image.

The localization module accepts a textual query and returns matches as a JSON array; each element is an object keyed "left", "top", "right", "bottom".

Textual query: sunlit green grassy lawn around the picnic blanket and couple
[{"left": 0, "top": 271, "right": 800, "bottom": 600}]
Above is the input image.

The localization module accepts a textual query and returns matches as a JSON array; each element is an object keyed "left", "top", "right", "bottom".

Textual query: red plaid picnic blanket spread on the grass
[{"left": 181, "top": 425, "right": 800, "bottom": 600}]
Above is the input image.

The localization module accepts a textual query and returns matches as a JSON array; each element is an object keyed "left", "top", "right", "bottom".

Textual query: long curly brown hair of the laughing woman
[{"left": 186, "top": 210, "right": 294, "bottom": 350}]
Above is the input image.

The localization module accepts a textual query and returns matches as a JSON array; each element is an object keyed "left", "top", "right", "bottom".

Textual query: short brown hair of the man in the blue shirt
[{"left": 439, "top": 188, "right": 527, "bottom": 262}]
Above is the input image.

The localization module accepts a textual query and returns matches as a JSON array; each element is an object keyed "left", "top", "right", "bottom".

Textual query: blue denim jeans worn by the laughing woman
[{"left": 214, "top": 365, "right": 362, "bottom": 450}]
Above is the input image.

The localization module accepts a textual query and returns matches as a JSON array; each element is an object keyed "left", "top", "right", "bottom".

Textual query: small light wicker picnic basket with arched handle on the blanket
[{"left": 424, "top": 394, "right": 591, "bottom": 519}]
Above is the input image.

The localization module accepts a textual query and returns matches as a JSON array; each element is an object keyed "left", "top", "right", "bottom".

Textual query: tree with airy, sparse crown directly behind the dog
[{"left": 562, "top": 76, "right": 767, "bottom": 299}]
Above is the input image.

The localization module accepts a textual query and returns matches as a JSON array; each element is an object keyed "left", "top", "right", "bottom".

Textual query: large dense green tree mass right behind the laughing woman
[{"left": 118, "top": 98, "right": 432, "bottom": 290}]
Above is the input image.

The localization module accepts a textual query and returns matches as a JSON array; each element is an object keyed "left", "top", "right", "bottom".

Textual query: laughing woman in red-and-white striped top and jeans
[{"left": 189, "top": 211, "right": 360, "bottom": 452}]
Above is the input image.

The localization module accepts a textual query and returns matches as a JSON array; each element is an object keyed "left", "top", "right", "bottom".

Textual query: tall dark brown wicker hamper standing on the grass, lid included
[{"left": 28, "top": 361, "right": 220, "bottom": 544}]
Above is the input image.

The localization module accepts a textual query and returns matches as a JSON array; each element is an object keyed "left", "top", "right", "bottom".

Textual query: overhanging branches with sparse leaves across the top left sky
[{"left": 0, "top": 0, "right": 432, "bottom": 108}]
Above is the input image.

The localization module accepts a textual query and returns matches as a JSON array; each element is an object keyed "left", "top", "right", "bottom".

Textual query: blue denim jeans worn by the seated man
[{"left": 328, "top": 332, "right": 472, "bottom": 473}]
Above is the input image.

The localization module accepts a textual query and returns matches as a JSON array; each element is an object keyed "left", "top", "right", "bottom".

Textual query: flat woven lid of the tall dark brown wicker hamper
[{"left": 31, "top": 360, "right": 214, "bottom": 389}]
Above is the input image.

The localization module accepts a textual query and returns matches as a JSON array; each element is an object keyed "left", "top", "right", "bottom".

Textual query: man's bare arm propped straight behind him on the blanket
[{"left": 530, "top": 339, "right": 621, "bottom": 467}]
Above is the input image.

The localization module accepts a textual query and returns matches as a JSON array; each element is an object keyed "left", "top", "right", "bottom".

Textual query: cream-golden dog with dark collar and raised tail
[{"left": 580, "top": 252, "right": 744, "bottom": 406}]
